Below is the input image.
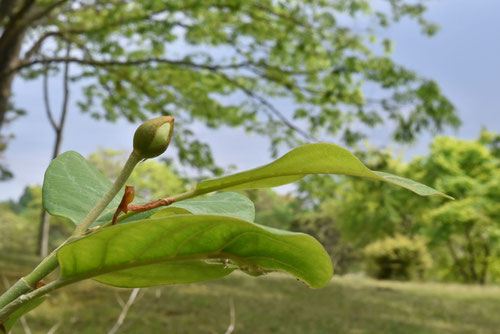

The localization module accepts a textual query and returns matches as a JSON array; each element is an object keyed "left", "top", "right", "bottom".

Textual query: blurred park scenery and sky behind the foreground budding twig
[{"left": 0, "top": 0, "right": 500, "bottom": 334}]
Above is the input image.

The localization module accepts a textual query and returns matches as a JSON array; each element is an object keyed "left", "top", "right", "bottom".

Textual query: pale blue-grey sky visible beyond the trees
[{"left": 0, "top": 0, "right": 500, "bottom": 201}]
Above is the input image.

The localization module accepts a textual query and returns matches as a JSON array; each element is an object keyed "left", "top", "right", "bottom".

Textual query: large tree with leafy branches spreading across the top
[{"left": 0, "top": 0, "right": 459, "bottom": 176}]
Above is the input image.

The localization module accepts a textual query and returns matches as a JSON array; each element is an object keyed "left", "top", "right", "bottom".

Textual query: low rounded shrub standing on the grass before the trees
[{"left": 364, "top": 235, "right": 432, "bottom": 280}]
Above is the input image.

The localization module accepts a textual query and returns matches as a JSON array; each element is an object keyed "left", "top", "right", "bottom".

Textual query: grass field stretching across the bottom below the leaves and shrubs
[{"left": 0, "top": 254, "right": 500, "bottom": 334}]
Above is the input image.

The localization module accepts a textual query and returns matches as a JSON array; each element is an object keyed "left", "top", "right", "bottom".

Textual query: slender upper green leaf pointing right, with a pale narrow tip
[{"left": 196, "top": 143, "right": 453, "bottom": 199}]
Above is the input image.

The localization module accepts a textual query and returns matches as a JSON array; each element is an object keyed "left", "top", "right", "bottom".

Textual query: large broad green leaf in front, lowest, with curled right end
[{"left": 57, "top": 215, "right": 333, "bottom": 288}]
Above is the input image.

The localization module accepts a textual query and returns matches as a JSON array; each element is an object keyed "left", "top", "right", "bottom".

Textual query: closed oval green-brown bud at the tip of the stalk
[{"left": 134, "top": 116, "right": 174, "bottom": 159}]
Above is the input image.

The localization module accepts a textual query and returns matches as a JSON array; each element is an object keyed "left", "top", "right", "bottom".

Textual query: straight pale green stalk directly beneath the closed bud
[{"left": 73, "top": 152, "right": 141, "bottom": 236}]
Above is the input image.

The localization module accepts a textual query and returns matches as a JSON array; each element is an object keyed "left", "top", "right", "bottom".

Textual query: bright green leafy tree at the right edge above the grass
[{"left": 412, "top": 131, "right": 500, "bottom": 284}]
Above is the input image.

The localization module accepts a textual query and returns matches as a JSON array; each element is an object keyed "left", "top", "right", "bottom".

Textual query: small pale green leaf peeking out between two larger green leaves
[{"left": 152, "top": 192, "right": 255, "bottom": 222}]
